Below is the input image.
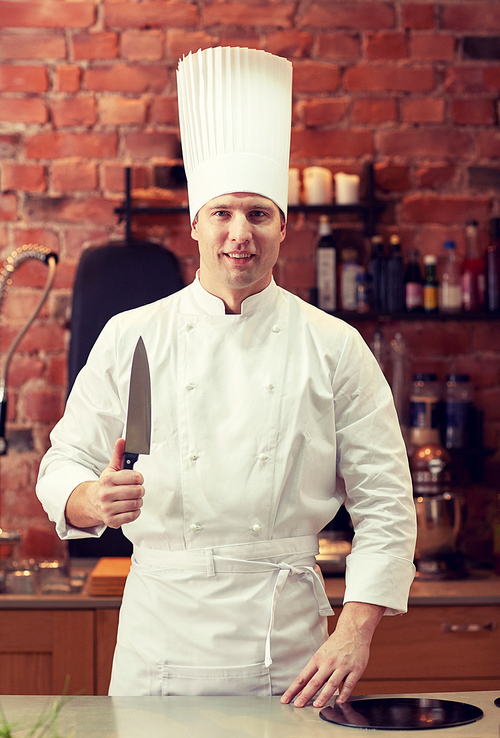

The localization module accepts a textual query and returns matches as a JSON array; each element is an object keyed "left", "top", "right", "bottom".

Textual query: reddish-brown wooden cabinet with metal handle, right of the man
[{"left": 329, "top": 605, "right": 500, "bottom": 694}]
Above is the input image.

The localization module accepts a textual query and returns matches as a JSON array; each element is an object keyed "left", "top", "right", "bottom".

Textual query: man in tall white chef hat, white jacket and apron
[{"left": 37, "top": 48, "right": 416, "bottom": 707}]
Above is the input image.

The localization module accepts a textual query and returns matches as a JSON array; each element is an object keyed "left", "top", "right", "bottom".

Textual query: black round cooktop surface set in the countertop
[{"left": 319, "top": 697, "right": 484, "bottom": 730}]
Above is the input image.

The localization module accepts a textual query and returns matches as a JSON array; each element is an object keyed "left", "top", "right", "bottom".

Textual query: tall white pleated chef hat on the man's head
[{"left": 177, "top": 47, "right": 292, "bottom": 222}]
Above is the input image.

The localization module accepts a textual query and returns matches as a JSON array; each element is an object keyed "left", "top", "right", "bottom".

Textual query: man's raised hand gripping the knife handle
[{"left": 66, "top": 438, "right": 144, "bottom": 528}]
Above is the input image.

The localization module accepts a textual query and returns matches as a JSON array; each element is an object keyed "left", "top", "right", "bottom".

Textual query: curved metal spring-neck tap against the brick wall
[{"left": 0, "top": 243, "right": 58, "bottom": 455}]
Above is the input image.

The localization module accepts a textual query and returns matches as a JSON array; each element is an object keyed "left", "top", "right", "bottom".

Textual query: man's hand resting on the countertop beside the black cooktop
[{"left": 281, "top": 602, "right": 385, "bottom": 707}]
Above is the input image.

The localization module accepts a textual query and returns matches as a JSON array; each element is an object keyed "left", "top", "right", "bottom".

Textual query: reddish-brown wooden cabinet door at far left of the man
[{"left": 0, "top": 609, "right": 94, "bottom": 694}]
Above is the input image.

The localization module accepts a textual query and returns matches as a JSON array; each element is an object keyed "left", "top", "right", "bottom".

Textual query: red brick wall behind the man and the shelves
[{"left": 0, "top": 0, "right": 500, "bottom": 552}]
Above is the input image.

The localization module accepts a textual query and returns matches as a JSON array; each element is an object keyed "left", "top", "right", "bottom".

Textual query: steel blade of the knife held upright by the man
[{"left": 123, "top": 336, "right": 151, "bottom": 469}]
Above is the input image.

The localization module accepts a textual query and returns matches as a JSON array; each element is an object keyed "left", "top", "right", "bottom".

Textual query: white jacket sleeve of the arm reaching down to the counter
[{"left": 334, "top": 330, "right": 416, "bottom": 615}]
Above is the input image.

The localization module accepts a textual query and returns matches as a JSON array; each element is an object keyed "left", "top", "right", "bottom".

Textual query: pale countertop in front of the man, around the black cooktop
[{"left": 0, "top": 692, "right": 500, "bottom": 738}]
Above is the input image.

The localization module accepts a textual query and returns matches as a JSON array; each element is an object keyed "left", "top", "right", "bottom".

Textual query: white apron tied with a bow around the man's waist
[{"left": 109, "top": 536, "right": 333, "bottom": 697}]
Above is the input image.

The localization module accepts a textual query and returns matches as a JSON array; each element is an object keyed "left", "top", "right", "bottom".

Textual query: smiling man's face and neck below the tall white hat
[{"left": 191, "top": 192, "right": 286, "bottom": 312}]
